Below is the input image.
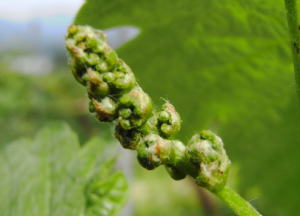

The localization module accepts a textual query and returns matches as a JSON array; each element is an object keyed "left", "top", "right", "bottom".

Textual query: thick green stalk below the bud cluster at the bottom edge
[{"left": 214, "top": 186, "right": 261, "bottom": 216}]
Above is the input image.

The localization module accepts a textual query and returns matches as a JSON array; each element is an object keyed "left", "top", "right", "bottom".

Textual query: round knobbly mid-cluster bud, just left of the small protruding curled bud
[{"left": 118, "top": 86, "right": 152, "bottom": 130}]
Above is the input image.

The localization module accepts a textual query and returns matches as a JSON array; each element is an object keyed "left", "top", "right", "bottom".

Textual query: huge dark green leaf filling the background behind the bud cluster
[{"left": 75, "top": 0, "right": 300, "bottom": 216}]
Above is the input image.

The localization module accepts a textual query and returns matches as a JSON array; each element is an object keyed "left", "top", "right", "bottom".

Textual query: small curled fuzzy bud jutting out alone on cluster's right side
[{"left": 158, "top": 102, "right": 181, "bottom": 138}]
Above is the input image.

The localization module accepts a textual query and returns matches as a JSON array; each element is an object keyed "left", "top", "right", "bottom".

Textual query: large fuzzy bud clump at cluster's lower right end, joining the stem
[{"left": 187, "top": 131, "right": 230, "bottom": 191}]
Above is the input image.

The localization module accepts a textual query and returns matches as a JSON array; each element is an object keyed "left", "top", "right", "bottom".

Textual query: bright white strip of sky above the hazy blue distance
[{"left": 0, "top": 0, "right": 84, "bottom": 22}]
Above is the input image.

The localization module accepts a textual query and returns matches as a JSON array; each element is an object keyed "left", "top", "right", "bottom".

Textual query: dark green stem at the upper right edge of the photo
[{"left": 285, "top": 0, "right": 300, "bottom": 99}]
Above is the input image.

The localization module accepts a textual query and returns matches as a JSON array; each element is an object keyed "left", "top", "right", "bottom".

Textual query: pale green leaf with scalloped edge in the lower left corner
[{"left": 0, "top": 124, "right": 127, "bottom": 216}]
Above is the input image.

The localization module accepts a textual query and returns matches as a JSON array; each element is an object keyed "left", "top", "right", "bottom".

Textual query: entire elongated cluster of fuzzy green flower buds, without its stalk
[{"left": 66, "top": 25, "right": 230, "bottom": 190}]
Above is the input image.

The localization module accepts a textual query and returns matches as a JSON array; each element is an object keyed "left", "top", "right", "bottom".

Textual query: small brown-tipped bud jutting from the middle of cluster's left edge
[{"left": 91, "top": 97, "right": 117, "bottom": 121}]
